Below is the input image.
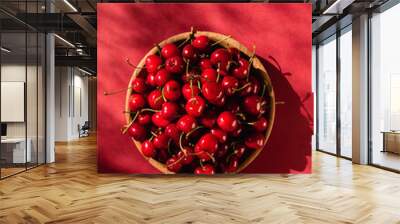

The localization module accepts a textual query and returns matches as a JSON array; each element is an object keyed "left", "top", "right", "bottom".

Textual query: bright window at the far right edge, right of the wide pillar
[{"left": 370, "top": 4, "right": 400, "bottom": 170}]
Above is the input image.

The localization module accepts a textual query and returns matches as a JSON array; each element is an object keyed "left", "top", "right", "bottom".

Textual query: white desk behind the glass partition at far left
[{"left": 1, "top": 138, "right": 32, "bottom": 163}]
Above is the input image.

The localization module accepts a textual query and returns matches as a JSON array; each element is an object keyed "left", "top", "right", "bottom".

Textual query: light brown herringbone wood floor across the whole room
[{"left": 0, "top": 137, "right": 400, "bottom": 224}]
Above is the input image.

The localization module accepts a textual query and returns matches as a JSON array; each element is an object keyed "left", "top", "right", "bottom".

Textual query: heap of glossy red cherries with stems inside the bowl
[{"left": 125, "top": 33, "right": 269, "bottom": 174}]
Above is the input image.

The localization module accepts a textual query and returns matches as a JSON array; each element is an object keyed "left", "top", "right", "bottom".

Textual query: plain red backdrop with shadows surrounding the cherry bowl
[{"left": 97, "top": 3, "right": 313, "bottom": 173}]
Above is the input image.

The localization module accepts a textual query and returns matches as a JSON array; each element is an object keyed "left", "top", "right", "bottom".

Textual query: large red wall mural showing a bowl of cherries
[{"left": 98, "top": 3, "right": 313, "bottom": 174}]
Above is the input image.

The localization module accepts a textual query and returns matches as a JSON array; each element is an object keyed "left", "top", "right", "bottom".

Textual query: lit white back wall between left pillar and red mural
[{"left": 55, "top": 67, "right": 88, "bottom": 141}]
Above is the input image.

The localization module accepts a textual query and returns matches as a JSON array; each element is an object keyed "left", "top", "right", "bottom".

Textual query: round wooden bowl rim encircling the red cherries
[{"left": 125, "top": 31, "right": 275, "bottom": 174}]
